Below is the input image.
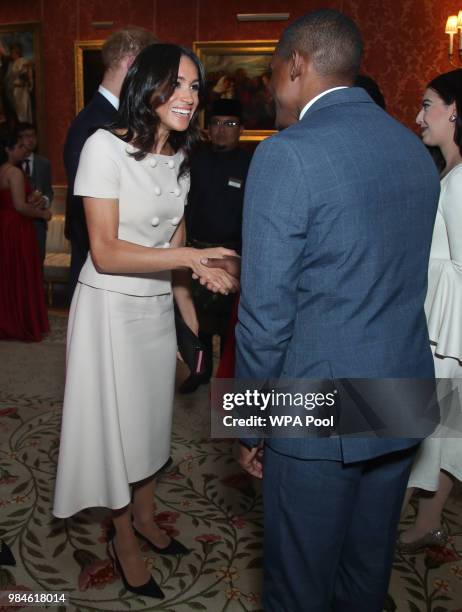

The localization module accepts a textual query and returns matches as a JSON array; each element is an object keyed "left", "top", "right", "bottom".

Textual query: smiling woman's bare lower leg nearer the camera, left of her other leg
[{"left": 112, "top": 506, "right": 151, "bottom": 586}]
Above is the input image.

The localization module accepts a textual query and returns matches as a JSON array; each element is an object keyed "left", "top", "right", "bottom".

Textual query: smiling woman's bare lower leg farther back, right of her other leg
[{"left": 132, "top": 477, "right": 171, "bottom": 548}]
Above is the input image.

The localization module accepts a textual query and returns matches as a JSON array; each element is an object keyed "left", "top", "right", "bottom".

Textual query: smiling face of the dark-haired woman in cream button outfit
[{"left": 155, "top": 55, "right": 199, "bottom": 132}]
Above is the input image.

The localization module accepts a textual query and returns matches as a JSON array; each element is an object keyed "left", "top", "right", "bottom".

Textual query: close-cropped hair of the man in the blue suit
[{"left": 276, "top": 9, "right": 363, "bottom": 79}]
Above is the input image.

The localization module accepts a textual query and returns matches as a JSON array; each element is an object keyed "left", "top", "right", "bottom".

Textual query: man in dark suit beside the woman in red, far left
[{"left": 18, "top": 122, "right": 53, "bottom": 264}]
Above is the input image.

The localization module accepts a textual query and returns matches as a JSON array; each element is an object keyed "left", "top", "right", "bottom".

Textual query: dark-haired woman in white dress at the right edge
[{"left": 398, "top": 70, "right": 462, "bottom": 553}]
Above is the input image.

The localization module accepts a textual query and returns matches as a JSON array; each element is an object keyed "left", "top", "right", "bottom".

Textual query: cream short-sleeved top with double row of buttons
[{"left": 74, "top": 129, "right": 189, "bottom": 296}]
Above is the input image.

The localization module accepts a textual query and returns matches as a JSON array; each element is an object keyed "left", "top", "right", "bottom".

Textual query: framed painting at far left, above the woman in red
[{"left": 0, "top": 23, "right": 43, "bottom": 142}]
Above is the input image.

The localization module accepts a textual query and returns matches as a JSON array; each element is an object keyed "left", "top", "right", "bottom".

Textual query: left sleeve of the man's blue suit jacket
[{"left": 236, "top": 134, "right": 309, "bottom": 379}]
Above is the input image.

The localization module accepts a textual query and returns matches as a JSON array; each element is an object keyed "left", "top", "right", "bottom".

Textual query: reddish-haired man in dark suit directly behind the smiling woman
[{"left": 64, "top": 27, "right": 157, "bottom": 298}]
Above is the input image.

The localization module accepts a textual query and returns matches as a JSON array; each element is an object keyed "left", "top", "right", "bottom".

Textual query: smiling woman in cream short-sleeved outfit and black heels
[{"left": 54, "top": 44, "right": 236, "bottom": 598}]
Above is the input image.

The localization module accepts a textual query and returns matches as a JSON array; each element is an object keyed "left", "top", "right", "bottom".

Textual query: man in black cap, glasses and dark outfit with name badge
[{"left": 179, "top": 98, "right": 252, "bottom": 393}]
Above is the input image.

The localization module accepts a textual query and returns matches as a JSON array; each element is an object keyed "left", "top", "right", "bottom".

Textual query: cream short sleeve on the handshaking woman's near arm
[{"left": 74, "top": 130, "right": 120, "bottom": 199}]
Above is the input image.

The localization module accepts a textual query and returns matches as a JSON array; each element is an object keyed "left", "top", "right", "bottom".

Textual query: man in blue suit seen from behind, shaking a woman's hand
[{"left": 236, "top": 10, "right": 439, "bottom": 612}]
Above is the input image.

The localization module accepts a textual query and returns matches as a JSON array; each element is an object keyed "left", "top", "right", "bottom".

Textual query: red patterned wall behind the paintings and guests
[{"left": 0, "top": 0, "right": 462, "bottom": 184}]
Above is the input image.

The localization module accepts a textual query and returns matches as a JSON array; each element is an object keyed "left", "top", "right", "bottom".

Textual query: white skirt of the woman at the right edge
[{"left": 408, "top": 345, "right": 462, "bottom": 491}]
